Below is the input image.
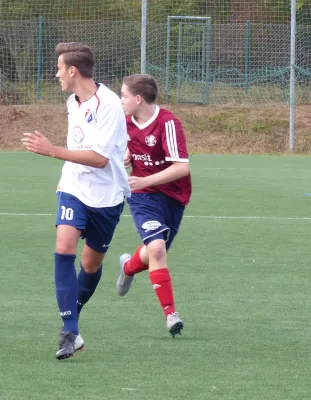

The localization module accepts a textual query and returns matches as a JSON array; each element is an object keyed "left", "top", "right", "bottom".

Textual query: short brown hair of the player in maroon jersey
[{"left": 123, "top": 74, "right": 158, "bottom": 104}]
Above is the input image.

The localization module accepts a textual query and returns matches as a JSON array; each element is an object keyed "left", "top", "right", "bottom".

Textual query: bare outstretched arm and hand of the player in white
[{"left": 22, "top": 131, "right": 109, "bottom": 168}]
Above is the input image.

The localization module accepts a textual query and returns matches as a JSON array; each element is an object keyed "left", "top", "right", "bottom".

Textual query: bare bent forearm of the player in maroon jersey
[{"left": 129, "top": 162, "right": 189, "bottom": 190}]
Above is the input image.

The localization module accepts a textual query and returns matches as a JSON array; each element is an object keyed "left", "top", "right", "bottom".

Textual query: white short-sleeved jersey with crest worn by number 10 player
[{"left": 57, "top": 84, "right": 130, "bottom": 208}]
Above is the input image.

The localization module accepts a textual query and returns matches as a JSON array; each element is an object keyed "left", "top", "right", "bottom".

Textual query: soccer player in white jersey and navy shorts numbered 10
[{"left": 22, "top": 42, "right": 130, "bottom": 359}]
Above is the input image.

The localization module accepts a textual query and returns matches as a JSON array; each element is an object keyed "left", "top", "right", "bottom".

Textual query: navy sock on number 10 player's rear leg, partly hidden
[{"left": 77, "top": 264, "right": 102, "bottom": 318}]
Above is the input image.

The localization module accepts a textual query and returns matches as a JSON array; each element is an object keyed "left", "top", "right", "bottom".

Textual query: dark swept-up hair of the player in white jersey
[{"left": 56, "top": 42, "right": 95, "bottom": 78}]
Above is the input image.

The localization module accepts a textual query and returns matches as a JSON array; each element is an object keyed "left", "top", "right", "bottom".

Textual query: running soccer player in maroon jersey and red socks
[{"left": 117, "top": 74, "right": 191, "bottom": 337}]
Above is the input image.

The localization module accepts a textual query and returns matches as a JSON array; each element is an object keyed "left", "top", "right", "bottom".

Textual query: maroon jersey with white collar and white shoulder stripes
[{"left": 126, "top": 107, "right": 191, "bottom": 205}]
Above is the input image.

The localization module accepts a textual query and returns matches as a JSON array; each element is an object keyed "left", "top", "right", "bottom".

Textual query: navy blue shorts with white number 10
[{"left": 56, "top": 192, "right": 124, "bottom": 253}]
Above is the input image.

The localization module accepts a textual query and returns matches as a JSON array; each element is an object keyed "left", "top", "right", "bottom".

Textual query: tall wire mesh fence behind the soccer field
[{"left": 0, "top": 0, "right": 311, "bottom": 105}]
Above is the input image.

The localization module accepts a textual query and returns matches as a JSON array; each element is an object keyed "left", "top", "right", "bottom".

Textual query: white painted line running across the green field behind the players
[{"left": 0, "top": 212, "right": 311, "bottom": 221}]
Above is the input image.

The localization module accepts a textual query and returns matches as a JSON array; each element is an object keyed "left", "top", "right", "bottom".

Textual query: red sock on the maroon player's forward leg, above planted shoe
[{"left": 149, "top": 268, "right": 176, "bottom": 317}]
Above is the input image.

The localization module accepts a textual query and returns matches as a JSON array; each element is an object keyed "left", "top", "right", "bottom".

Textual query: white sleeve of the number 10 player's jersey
[{"left": 92, "top": 103, "right": 125, "bottom": 159}]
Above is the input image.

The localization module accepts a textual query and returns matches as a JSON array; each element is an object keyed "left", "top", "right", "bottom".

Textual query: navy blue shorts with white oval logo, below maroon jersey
[{"left": 127, "top": 193, "right": 185, "bottom": 250}]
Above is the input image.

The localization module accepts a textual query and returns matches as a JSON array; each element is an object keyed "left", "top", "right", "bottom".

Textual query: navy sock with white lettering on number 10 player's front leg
[{"left": 54, "top": 253, "right": 79, "bottom": 335}]
